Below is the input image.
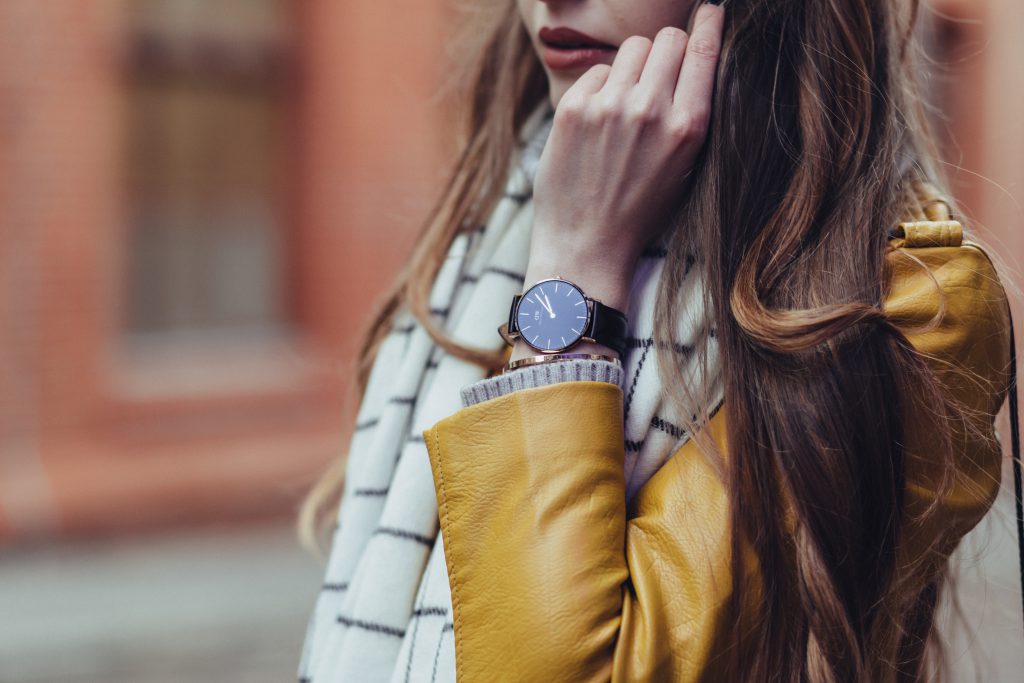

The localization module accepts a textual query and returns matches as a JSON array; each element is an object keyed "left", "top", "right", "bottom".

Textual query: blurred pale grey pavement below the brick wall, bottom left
[{"left": 0, "top": 521, "right": 323, "bottom": 683}]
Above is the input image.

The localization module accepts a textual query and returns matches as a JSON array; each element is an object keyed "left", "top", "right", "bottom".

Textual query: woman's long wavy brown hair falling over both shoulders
[{"left": 299, "top": 0, "right": 974, "bottom": 682}]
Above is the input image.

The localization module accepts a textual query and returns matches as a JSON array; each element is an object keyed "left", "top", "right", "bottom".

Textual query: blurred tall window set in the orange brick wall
[{"left": 126, "top": 0, "right": 293, "bottom": 336}]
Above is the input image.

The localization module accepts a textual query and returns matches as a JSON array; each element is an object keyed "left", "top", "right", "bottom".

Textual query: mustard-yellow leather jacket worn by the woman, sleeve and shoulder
[{"left": 423, "top": 201, "right": 1010, "bottom": 683}]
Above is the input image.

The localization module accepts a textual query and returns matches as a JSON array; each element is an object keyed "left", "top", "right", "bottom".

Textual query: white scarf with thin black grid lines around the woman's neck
[{"left": 298, "top": 104, "right": 721, "bottom": 683}]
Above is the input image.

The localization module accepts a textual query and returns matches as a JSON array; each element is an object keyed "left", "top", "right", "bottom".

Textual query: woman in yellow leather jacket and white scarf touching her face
[{"left": 299, "top": 0, "right": 1012, "bottom": 681}]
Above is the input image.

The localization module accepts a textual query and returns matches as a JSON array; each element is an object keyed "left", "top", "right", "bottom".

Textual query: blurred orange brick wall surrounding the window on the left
[{"left": 0, "top": 0, "right": 452, "bottom": 540}]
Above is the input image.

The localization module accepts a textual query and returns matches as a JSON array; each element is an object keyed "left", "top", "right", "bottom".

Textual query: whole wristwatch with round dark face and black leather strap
[{"left": 498, "top": 278, "right": 628, "bottom": 356}]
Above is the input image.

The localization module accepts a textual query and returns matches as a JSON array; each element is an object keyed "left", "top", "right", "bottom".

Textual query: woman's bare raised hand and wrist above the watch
[{"left": 526, "top": 4, "right": 723, "bottom": 308}]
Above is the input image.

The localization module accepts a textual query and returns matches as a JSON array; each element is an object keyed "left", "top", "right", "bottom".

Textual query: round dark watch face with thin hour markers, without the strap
[{"left": 516, "top": 280, "right": 589, "bottom": 351}]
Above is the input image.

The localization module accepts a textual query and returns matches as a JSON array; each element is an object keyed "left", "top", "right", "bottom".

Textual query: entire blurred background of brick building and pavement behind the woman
[{"left": 0, "top": 0, "right": 1024, "bottom": 682}]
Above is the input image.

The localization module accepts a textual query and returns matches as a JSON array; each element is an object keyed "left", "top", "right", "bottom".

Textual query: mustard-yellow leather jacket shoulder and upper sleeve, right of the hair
[{"left": 884, "top": 216, "right": 1013, "bottom": 562}]
